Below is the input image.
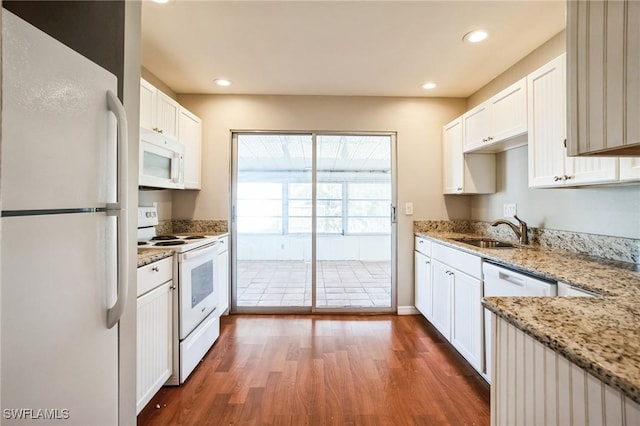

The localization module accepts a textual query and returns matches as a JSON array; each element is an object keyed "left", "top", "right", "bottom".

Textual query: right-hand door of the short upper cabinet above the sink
[{"left": 489, "top": 78, "right": 527, "bottom": 143}]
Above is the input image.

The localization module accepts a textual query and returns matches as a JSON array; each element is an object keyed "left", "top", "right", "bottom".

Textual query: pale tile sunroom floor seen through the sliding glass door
[{"left": 237, "top": 260, "right": 391, "bottom": 308}]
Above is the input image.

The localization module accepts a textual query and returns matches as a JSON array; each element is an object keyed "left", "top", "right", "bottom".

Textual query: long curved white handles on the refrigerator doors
[{"left": 107, "top": 90, "right": 129, "bottom": 328}]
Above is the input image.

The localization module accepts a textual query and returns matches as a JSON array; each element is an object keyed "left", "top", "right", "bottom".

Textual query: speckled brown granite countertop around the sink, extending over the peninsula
[{"left": 416, "top": 232, "right": 640, "bottom": 403}]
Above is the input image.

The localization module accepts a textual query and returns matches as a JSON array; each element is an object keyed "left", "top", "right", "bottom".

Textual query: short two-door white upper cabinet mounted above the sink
[{"left": 462, "top": 78, "right": 527, "bottom": 152}]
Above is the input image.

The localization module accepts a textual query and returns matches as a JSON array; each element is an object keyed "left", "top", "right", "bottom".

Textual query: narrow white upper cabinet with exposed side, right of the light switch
[{"left": 442, "top": 118, "right": 496, "bottom": 194}]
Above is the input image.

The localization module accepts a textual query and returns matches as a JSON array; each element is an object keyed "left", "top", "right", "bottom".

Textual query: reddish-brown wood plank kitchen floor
[{"left": 138, "top": 315, "right": 489, "bottom": 426}]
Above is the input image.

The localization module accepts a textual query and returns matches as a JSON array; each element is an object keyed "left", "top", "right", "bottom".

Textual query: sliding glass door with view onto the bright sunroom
[{"left": 232, "top": 133, "right": 395, "bottom": 312}]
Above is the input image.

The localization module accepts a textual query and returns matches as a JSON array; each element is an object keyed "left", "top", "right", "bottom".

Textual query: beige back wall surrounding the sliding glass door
[{"left": 173, "top": 95, "right": 470, "bottom": 306}]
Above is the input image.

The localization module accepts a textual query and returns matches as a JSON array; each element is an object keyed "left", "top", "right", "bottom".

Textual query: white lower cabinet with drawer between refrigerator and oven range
[{"left": 136, "top": 258, "right": 174, "bottom": 413}]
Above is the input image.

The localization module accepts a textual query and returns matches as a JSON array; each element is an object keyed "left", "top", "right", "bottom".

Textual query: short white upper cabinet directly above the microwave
[{"left": 140, "top": 78, "right": 180, "bottom": 140}]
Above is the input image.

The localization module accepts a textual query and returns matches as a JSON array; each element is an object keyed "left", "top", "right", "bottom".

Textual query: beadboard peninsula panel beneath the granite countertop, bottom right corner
[{"left": 491, "top": 314, "right": 640, "bottom": 426}]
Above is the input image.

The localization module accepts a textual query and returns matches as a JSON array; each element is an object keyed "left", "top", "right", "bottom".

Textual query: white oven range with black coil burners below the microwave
[{"left": 138, "top": 207, "right": 220, "bottom": 385}]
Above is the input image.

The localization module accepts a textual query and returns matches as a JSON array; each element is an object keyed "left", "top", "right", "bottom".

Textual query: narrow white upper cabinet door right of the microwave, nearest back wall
[{"left": 178, "top": 107, "right": 202, "bottom": 189}]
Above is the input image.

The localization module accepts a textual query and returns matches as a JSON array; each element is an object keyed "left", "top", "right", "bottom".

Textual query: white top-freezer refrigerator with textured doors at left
[{"left": 0, "top": 10, "right": 128, "bottom": 426}]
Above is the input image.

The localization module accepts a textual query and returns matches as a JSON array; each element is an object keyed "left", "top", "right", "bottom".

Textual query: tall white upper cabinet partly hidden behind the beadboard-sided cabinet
[{"left": 528, "top": 54, "right": 618, "bottom": 187}]
